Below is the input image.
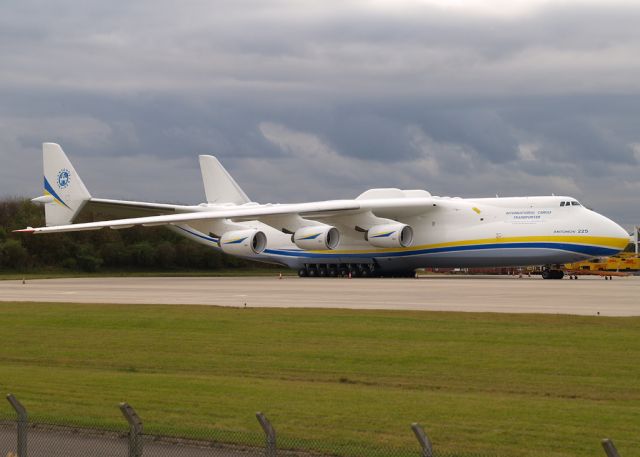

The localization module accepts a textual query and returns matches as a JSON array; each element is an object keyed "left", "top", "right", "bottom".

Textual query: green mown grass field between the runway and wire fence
[{"left": 0, "top": 303, "right": 640, "bottom": 457}]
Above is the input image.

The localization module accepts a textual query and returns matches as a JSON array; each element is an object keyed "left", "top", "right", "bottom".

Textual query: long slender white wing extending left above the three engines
[{"left": 15, "top": 200, "right": 360, "bottom": 233}]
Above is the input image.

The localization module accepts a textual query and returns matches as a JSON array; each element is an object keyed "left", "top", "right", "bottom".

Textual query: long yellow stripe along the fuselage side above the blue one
[{"left": 309, "top": 235, "right": 629, "bottom": 254}]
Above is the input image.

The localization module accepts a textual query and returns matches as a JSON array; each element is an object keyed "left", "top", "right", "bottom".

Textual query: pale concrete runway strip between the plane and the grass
[{"left": 0, "top": 276, "right": 640, "bottom": 316}]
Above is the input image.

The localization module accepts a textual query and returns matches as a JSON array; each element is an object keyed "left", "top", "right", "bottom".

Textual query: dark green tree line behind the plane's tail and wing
[{"left": 0, "top": 198, "right": 266, "bottom": 272}]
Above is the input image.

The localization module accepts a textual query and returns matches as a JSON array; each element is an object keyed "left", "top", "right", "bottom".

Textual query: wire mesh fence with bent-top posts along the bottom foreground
[{"left": 0, "top": 395, "right": 620, "bottom": 457}]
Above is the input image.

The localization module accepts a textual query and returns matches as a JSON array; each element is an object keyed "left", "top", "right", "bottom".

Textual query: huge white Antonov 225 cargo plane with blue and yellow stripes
[{"left": 19, "top": 143, "right": 629, "bottom": 279}]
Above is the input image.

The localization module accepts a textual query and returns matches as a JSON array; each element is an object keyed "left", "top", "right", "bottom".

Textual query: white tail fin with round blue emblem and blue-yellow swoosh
[{"left": 40, "top": 143, "right": 91, "bottom": 226}]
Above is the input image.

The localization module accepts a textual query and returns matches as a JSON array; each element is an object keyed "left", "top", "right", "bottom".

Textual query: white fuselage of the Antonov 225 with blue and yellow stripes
[{"left": 174, "top": 196, "right": 629, "bottom": 271}]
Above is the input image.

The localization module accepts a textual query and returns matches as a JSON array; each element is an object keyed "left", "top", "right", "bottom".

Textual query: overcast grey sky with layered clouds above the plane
[{"left": 0, "top": 0, "right": 640, "bottom": 226}]
